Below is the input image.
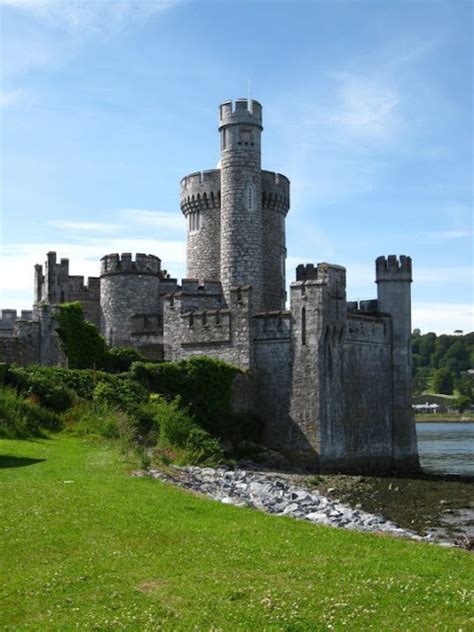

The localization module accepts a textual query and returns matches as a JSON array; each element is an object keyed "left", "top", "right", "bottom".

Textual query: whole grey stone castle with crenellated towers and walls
[{"left": 0, "top": 99, "right": 418, "bottom": 472}]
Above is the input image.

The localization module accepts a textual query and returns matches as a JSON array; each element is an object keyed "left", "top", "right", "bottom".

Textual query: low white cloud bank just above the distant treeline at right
[{"left": 412, "top": 301, "right": 474, "bottom": 334}]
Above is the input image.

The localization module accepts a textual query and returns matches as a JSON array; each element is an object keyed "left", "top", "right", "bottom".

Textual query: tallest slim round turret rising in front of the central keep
[{"left": 219, "top": 99, "right": 264, "bottom": 311}]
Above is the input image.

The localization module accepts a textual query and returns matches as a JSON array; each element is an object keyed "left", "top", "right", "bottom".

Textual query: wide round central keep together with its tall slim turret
[{"left": 181, "top": 99, "right": 290, "bottom": 311}]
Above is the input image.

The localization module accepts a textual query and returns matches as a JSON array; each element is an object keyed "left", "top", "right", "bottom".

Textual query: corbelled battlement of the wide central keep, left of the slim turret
[{"left": 181, "top": 169, "right": 221, "bottom": 215}]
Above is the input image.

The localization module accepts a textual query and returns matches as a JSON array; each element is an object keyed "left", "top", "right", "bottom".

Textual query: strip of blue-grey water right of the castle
[{"left": 416, "top": 423, "right": 474, "bottom": 476}]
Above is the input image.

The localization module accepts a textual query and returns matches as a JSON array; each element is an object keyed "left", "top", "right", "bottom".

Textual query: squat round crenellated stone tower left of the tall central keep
[{"left": 100, "top": 253, "right": 161, "bottom": 347}]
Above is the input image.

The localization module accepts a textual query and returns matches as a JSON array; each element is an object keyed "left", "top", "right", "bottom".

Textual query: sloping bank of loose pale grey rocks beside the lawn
[{"left": 148, "top": 467, "right": 425, "bottom": 540}]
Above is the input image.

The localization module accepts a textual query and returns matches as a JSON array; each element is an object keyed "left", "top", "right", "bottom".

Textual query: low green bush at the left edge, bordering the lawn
[{"left": 0, "top": 387, "right": 61, "bottom": 439}]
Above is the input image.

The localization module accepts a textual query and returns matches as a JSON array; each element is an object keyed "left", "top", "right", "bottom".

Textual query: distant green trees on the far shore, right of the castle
[{"left": 411, "top": 329, "right": 474, "bottom": 408}]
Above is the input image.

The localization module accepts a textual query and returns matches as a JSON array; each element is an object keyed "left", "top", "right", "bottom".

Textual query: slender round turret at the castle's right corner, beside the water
[{"left": 375, "top": 255, "right": 419, "bottom": 471}]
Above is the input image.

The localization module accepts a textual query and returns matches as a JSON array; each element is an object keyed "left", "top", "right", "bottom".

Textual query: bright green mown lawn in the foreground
[{"left": 0, "top": 435, "right": 474, "bottom": 631}]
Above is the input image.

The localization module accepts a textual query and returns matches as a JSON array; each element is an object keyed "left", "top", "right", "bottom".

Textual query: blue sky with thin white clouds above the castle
[{"left": 0, "top": 0, "right": 473, "bottom": 333}]
